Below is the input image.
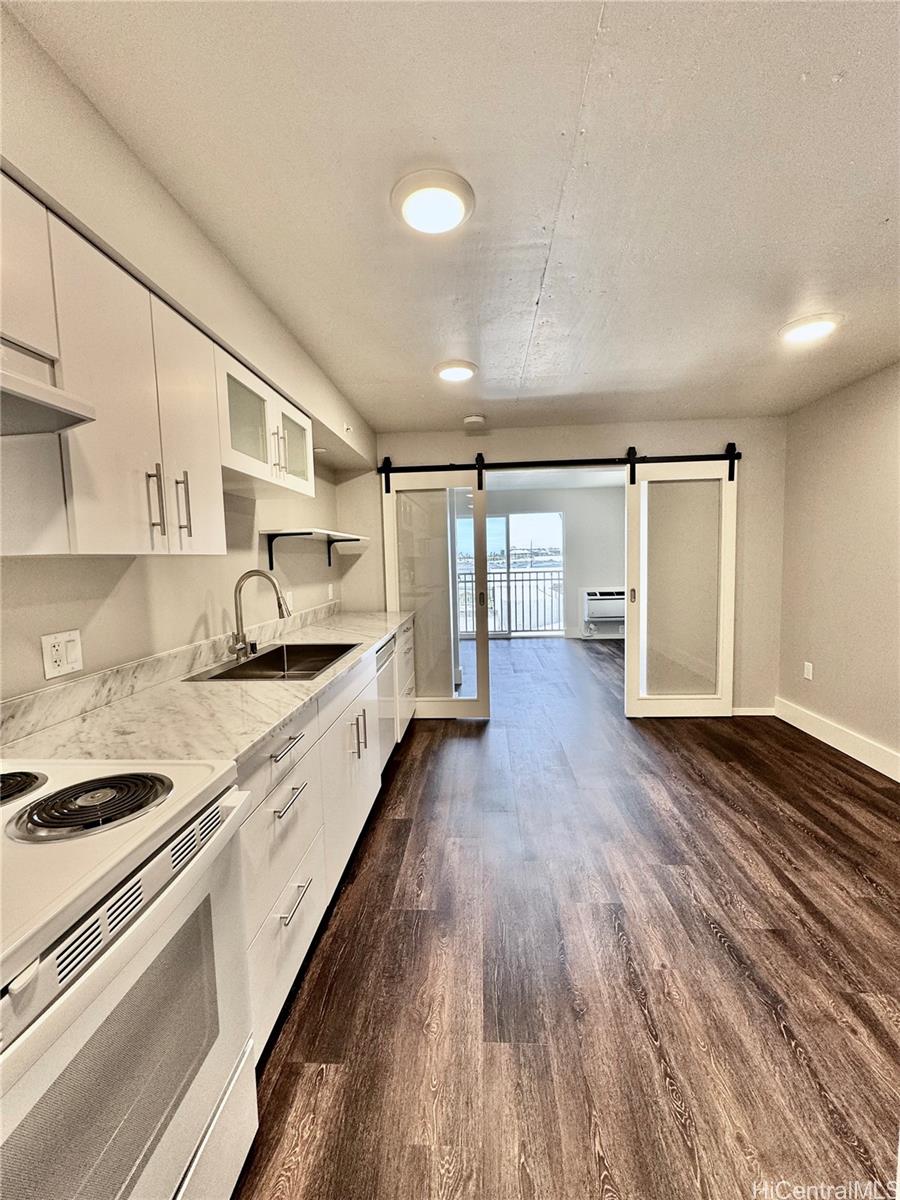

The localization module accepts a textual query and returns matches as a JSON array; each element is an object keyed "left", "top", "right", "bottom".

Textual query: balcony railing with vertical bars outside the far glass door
[{"left": 456, "top": 569, "right": 565, "bottom": 637}]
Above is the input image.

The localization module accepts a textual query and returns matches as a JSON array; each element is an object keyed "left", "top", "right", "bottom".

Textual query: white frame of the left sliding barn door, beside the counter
[{"left": 382, "top": 467, "right": 491, "bottom": 718}]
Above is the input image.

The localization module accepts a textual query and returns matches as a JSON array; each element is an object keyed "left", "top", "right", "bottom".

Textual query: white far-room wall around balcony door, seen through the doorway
[{"left": 487, "top": 476, "right": 625, "bottom": 637}]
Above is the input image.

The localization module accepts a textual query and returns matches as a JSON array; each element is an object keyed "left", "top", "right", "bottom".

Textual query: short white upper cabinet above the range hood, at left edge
[{"left": 0, "top": 175, "right": 59, "bottom": 360}]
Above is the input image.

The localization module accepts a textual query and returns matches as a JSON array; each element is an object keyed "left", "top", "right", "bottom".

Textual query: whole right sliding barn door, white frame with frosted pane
[{"left": 625, "top": 462, "right": 737, "bottom": 716}]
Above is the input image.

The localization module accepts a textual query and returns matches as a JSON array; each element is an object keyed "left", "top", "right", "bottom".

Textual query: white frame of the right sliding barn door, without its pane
[{"left": 625, "top": 461, "right": 738, "bottom": 716}]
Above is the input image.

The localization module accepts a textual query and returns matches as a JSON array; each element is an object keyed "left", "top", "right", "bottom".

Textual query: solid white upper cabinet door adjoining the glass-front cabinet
[{"left": 150, "top": 296, "right": 226, "bottom": 554}]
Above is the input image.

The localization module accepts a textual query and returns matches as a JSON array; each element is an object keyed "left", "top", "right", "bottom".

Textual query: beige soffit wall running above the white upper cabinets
[{"left": 2, "top": 10, "right": 374, "bottom": 462}]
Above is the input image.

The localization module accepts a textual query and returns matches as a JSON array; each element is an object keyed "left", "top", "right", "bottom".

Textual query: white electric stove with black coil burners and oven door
[{"left": 0, "top": 760, "right": 257, "bottom": 1200}]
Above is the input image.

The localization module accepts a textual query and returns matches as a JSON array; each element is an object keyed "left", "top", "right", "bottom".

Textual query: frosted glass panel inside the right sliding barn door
[{"left": 642, "top": 479, "right": 721, "bottom": 696}]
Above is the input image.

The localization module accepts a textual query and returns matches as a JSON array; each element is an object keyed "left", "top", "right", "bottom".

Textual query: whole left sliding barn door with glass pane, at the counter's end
[{"left": 383, "top": 470, "right": 491, "bottom": 716}]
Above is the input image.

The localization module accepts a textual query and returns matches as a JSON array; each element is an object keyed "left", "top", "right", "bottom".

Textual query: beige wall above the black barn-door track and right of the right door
[{"left": 374, "top": 416, "right": 786, "bottom": 708}]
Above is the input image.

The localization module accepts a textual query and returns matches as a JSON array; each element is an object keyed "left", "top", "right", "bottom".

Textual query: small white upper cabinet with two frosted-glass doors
[{"left": 216, "top": 348, "right": 316, "bottom": 496}]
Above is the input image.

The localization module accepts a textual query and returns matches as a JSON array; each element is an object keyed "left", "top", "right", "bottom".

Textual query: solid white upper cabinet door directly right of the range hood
[{"left": 50, "top": 216, "right": 169, "bottom": 554}]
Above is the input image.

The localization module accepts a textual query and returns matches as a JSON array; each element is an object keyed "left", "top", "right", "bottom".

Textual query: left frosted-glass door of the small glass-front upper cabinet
[{"left": 216, "top": 347, "right": 281, "bottom": 482}]
